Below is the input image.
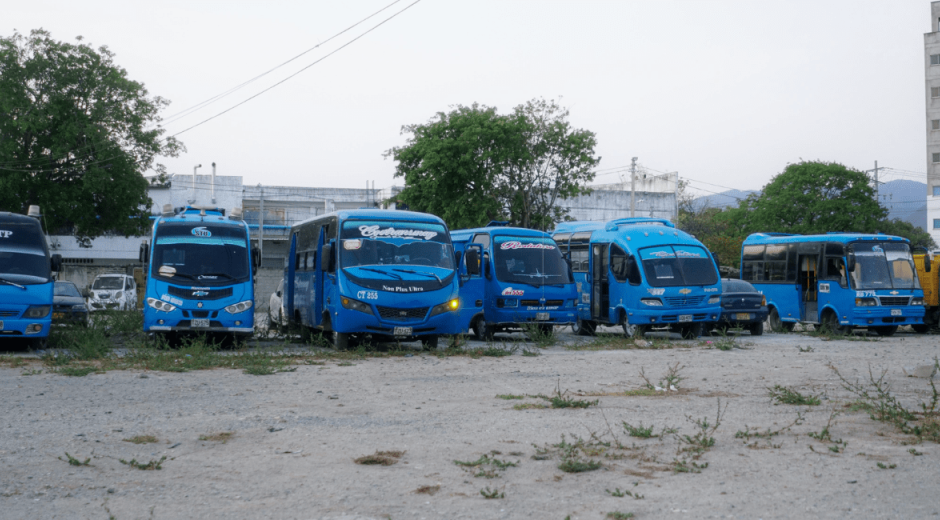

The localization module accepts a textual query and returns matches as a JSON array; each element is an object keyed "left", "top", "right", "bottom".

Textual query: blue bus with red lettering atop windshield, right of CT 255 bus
[{"left": 450, "top": 223, "right": 578, "bottom": 341}]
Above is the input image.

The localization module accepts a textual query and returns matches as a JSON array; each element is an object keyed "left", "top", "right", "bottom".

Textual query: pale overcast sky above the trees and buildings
[{"left": 0, "top": 0, "right": 930, "bottom": 194}]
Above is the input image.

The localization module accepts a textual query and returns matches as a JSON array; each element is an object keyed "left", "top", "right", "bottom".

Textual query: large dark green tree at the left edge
[{"left": 0, "top": 29, "right": 185, "bottom": 238}]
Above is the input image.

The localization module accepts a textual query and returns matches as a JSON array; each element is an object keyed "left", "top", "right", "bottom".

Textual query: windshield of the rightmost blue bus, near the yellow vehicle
[{"left": 852, "top": 242, "right": 920, "bottom": 289}]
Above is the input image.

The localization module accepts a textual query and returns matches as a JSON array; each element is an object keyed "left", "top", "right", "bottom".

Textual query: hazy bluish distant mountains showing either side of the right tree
[{"left": 692, "top": 180, "right": 927, "bottom": 229}]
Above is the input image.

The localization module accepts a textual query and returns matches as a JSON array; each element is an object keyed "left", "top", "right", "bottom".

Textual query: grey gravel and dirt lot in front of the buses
[{"left": 0, "top": 329, "right": 940, "bottom": 520}]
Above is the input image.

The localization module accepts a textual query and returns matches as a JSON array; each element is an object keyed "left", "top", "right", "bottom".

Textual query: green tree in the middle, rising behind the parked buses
[{"left": 385, "top": 100, "right": 600, "bottom": 229}]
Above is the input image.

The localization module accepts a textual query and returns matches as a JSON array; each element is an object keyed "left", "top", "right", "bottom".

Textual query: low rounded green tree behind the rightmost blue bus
[{"left": 727, "top": 162, "right": 887, "bottom": 234}]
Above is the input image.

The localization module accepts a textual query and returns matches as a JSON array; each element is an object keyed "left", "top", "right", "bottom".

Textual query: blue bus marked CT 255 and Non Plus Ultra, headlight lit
[{"left": 284, "top": 209, "right": 459, "bottom": 350}]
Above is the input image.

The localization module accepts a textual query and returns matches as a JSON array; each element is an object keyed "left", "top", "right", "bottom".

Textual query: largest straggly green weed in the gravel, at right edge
[{"left": 829, "top": 358, "right": 940, "bottom": 443}]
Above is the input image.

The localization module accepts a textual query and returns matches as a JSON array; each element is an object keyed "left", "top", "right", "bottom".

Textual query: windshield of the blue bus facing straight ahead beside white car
[{"left": 151, "top": 222, "right": 251, "bottom": 285}]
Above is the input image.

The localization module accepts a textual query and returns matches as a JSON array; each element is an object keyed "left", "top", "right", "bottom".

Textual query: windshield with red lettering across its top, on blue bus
[{"left": 493, "top": 236, "right": 571, "bottom": 287}]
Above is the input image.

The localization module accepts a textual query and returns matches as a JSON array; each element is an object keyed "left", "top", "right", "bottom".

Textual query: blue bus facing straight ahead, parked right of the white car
[{"left": 140, "top": 206, "right": 260, "bottom": 339}]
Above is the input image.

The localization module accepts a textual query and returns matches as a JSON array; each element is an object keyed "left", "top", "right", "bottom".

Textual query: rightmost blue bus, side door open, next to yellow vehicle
[{"left": 741, "top": 233, "right": 924, "bottom": 336}]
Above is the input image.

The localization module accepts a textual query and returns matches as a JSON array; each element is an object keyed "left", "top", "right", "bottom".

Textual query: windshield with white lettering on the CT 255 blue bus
[{"left": 340, "top": 220, "right": 454, "bottom": 270}]
